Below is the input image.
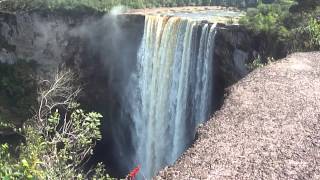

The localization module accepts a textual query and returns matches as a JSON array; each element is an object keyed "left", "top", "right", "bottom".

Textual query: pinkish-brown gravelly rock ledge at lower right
[{"left": 154, "top": 52, "right": 320, "bottom": 180}]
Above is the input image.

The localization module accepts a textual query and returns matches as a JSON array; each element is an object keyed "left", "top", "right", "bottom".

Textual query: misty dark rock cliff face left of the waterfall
[{"left": 0, "top": 12, "right": 144, "bottom": 174}]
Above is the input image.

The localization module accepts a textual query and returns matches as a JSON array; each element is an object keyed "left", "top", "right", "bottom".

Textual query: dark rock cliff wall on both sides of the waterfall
[{"left": 0, "top": 9, "right": 254, "bottom": 175}]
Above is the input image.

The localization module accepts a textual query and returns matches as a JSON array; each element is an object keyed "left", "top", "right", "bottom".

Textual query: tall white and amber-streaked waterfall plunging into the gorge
[{"left": 128, "top": 15, "right": 216, "bottom": 178}]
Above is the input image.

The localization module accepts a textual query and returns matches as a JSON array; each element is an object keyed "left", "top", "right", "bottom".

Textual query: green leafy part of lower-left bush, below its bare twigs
[{"left": 0, "top": 109, "right": 106, "bottom": 179}]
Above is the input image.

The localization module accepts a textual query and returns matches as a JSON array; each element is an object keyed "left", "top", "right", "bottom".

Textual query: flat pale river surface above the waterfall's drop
[{"left": 123, "top": 6, "right": 245, "bottom": 24}]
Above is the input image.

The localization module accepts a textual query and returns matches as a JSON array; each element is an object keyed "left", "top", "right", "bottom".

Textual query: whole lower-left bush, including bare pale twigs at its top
[{"left": 0, "top": 71, "right": 110, "bottom": 180}]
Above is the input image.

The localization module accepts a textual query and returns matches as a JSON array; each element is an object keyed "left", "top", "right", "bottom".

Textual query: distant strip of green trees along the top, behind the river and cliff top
[{"left": 0, "top": 0, "right": 254, "bottom": 11}]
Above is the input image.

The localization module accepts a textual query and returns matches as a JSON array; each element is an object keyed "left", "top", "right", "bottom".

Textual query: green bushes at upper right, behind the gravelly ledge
[{"left": 240, "top": 0, "right": 320, "bottom": 62}]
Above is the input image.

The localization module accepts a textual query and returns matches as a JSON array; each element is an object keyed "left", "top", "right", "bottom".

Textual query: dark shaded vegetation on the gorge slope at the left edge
[{"left": 0, "top": 60, "right": 37, "bottom": 123}]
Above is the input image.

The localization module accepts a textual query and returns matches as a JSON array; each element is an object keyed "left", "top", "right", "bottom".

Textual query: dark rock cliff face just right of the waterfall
[{"left": 214, "top": 24, "right": 255, "bottom": 86}]
